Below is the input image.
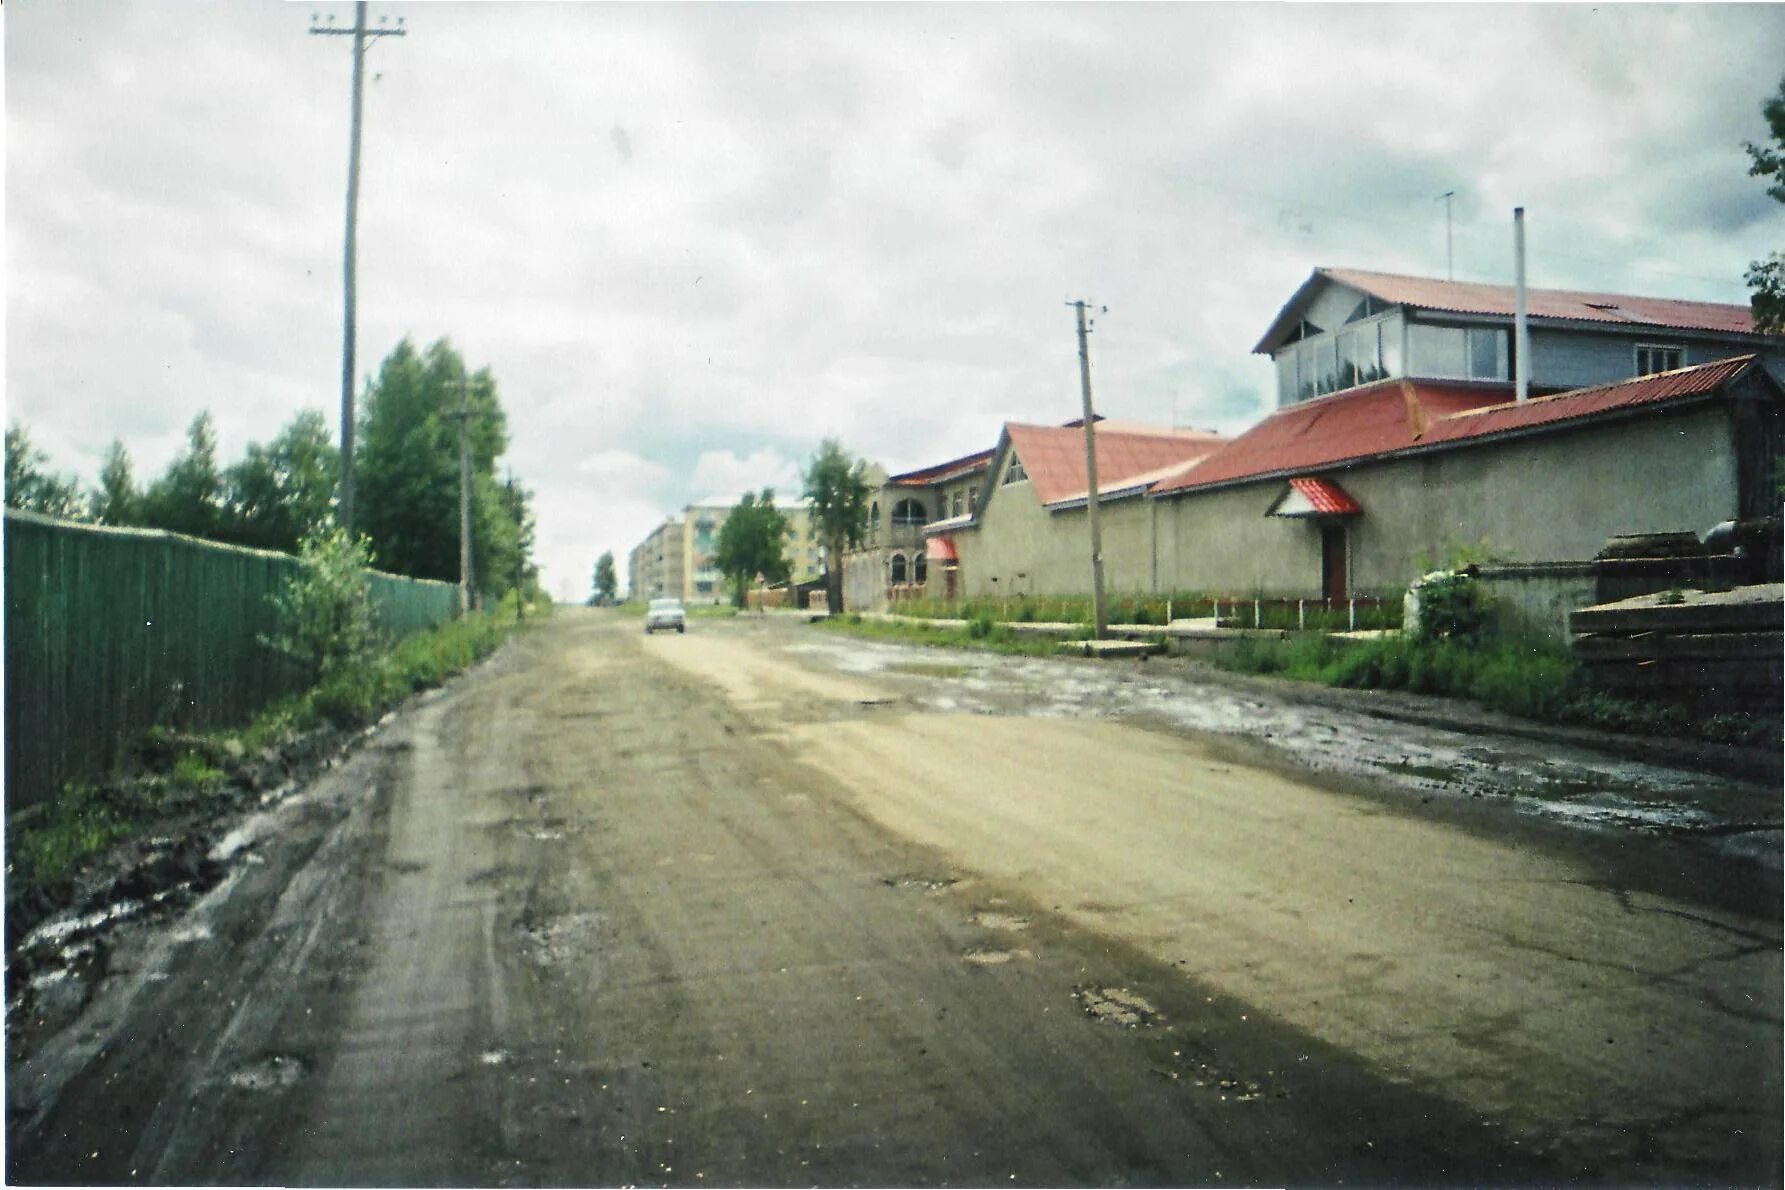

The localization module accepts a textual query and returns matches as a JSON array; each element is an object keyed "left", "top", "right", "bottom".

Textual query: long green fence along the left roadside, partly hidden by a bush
[{"left": 5, "top": 508, "right": 455, "bottom": 814}]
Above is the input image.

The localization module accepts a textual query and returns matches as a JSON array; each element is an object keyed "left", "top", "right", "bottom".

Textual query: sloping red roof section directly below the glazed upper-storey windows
[{"left": 1142, "top": 380, "right": 1512, "bottom": 494}]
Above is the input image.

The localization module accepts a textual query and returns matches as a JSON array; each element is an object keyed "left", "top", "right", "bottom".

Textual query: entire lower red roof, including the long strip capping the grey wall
[{"left": 1153, "top": 355, "right": 1756, "bottom": 496}]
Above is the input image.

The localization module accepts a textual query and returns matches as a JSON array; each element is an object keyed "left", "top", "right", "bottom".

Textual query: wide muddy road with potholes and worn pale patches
[{"left": 7, "top": 610, "right": 1781, "bottom": 1185}]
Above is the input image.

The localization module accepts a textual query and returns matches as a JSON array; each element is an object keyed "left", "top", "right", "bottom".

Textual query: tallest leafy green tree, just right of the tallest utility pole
[{"left": 353, "top": 339, "right": 521, "bottom": 596}]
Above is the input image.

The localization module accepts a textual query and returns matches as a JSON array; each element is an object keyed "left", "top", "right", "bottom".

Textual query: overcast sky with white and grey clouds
[{"left": 4, "top": 0, "right": 1785, "bottom": 599}]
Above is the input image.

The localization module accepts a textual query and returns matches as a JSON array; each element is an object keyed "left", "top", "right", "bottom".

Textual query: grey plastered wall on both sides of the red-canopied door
[{"left": 1158, "top": 407, "right": 1737, "bottom": 598}]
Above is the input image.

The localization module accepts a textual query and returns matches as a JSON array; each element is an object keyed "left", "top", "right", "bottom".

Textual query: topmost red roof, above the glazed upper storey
[{"left": 1253, "top": 268, "right": 1756, "bottom": 351}]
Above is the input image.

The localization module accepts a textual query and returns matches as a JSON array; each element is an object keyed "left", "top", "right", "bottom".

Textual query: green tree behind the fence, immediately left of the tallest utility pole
[{"left": 223, "top": 409, "right": 341, "bottom": 553}]
